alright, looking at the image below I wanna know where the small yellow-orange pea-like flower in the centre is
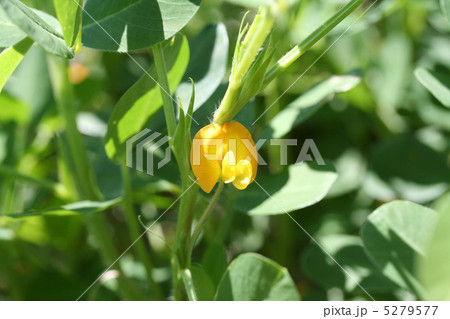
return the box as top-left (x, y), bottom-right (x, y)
top-left (191, 122), bottom-right (258, 193)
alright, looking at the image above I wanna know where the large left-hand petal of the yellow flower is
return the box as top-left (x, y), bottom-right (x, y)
top-left (190, 123), bottom-right (223, 193)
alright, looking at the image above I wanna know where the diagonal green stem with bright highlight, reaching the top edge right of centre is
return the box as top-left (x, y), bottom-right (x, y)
top-left (263, 0), bottom-right (366, 87)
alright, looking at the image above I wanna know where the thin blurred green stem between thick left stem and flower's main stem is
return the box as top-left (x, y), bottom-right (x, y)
top-left (122, 165), bottom-right (164, 300)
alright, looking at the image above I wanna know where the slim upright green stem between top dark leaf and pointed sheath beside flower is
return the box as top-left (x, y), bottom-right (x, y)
top-left (152, 43), bottom-right (176, 137)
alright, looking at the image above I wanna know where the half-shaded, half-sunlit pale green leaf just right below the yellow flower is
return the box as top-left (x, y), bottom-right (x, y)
top-left (234, 163), bottom-right (337, 215)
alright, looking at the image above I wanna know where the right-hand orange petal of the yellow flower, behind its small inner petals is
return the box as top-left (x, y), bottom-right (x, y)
top-left (223, 122), bottom-right (258, 188)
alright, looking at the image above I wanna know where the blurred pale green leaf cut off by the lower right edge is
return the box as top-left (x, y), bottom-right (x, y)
top-left (418, 193), bottom-right (450, 301)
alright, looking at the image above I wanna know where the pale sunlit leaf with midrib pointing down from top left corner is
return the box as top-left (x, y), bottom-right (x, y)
top-left (0, 0), bottom-right (74, 59)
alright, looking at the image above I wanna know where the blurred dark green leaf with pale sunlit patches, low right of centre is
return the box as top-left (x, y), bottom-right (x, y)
top-left (302, 235), bottom-right (397, 297)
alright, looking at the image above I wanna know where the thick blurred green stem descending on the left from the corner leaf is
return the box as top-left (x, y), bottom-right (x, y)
top-left (48, 56), bottom-right (143, 300)
